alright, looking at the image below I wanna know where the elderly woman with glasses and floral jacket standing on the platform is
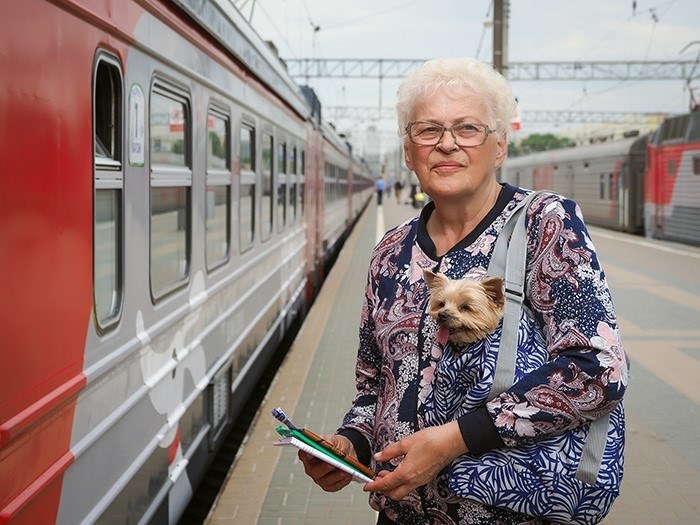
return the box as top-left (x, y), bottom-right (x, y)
top-left (300, 59), bottom-right (627, 525)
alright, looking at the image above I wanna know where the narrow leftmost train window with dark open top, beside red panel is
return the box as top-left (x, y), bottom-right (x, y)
top-left (93, 54), bottom-right (124, 329)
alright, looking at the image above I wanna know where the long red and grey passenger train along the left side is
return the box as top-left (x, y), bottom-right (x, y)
top-left (0, 0), bottom-right (373, 525)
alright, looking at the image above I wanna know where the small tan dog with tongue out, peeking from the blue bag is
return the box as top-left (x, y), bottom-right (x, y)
top-left (423, 270), bottom-right (505, 346)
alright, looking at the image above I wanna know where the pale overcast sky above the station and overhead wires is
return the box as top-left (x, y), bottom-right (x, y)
top-left (234, 0), bottom-right (700, 155)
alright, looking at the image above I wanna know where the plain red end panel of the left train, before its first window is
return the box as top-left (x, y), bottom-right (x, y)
top-left (0, 0), bottom-right (140, 524)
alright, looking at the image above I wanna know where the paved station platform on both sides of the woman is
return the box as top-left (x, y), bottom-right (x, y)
top-left (205, 195), bottom-right (700, 525)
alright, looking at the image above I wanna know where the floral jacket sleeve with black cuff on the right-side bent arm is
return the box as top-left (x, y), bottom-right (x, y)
top-left (470, 194), bottom-right (628, 453)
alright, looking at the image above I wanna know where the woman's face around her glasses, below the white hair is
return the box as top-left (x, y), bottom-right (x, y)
top-left (404, 90), bottom-right (507, 201)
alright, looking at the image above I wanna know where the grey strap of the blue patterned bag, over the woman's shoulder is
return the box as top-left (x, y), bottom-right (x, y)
top-left (487, 192), bottom-right (610, 485)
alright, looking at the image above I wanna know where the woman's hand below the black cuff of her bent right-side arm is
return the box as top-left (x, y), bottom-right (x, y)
top-left (364, 421), bottom-right (468, 501)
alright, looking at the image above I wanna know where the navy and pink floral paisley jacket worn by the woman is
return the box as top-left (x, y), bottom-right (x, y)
top-left (339, 185), bottom-right (627, 525)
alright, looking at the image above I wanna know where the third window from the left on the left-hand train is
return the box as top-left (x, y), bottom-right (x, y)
top-left (206, 110), bottom-right (231, 270)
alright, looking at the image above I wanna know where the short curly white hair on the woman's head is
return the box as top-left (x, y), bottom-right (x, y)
top-left (396, 58), bottom-right (517, 137)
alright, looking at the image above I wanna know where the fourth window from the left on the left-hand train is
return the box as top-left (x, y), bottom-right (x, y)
top-left (238, 124), bottom-right (255, 251)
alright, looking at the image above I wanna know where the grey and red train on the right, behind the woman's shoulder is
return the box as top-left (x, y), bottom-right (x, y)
top-left (502, 111), bottom-right (700, 245)
